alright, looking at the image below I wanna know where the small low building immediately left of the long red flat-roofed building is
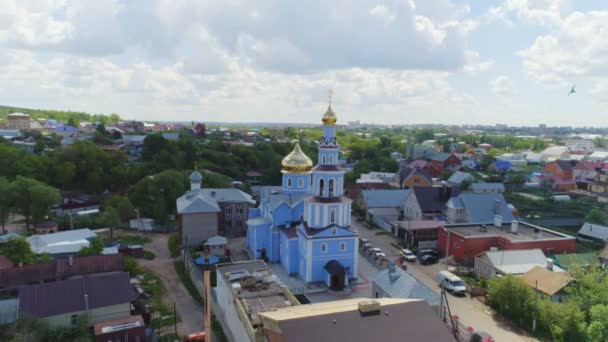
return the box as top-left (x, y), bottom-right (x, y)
top-left (394, 220), bottom-right (446, 248)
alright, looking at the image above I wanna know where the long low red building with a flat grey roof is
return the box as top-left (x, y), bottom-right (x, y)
top-left (438, 219), bottom-right (576, 265)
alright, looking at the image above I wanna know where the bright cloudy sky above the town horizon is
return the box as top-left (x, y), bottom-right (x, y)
top-left (0, 0), bottom-right (608, 126)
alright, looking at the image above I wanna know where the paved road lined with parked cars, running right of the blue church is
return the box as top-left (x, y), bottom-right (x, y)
top-left (352, 217), bottom-right (534, 342)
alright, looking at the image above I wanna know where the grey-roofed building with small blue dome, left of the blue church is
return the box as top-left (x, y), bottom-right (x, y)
top-left (176, 170), bottom-right (255, 246)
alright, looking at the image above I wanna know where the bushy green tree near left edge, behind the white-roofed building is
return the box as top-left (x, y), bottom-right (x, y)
top-left (10, 176), bottom-right (61, 229)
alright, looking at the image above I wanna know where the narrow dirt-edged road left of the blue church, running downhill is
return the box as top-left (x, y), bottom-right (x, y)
top-left (139, 234), bottom-right (204, 336)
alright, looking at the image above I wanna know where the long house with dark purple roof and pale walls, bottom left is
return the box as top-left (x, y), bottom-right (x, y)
top-left (19, 272), bottom-right (135, 327)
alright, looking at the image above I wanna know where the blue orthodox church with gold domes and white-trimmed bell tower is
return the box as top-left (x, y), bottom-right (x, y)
top-left (247, 104), bottom-right (359, 290)
